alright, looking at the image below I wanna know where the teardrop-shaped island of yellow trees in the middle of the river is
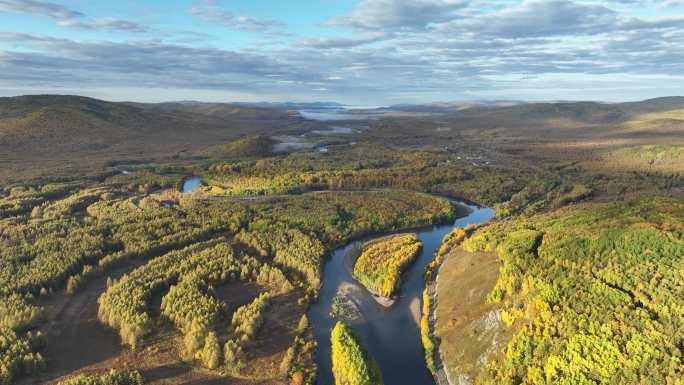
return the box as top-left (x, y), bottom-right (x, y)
top-left (354, 234), bottom-right (423, 305)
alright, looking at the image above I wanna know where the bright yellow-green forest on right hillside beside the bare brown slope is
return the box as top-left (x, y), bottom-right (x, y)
top-left (452, 197), bottom-right (684, 384)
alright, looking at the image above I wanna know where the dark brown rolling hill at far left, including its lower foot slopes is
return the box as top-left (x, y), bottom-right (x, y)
top-left (0, 95), bottom-right (312, 182)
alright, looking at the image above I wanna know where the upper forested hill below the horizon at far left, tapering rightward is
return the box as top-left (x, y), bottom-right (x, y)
top-left (0, 95), bottom-right (299, 159)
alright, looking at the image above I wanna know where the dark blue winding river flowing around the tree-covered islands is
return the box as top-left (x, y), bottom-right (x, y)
top-left (309, 205), bottom-right (494, 385)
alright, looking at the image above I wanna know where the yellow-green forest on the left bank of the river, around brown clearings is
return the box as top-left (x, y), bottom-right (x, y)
top-left (0, 172), bottom-right (454, 384)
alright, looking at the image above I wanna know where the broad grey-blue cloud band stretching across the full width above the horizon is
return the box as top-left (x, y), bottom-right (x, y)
top-left (0, 23), bottom-right (684, 104)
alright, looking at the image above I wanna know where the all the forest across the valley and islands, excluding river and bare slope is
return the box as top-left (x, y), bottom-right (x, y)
top-left (0, 94), bottom-right (684, 385)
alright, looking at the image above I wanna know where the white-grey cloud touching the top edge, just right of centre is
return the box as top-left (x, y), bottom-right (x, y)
top-left (329, 0), bottom-right (466, 30)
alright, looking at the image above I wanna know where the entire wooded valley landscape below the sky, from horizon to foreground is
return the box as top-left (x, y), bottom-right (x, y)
top-left (0, 96), bottom-right (684, 385)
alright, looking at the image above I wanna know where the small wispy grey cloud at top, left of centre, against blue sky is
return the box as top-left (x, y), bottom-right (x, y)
top-left (190, 0), bottom-right (285, 32)
